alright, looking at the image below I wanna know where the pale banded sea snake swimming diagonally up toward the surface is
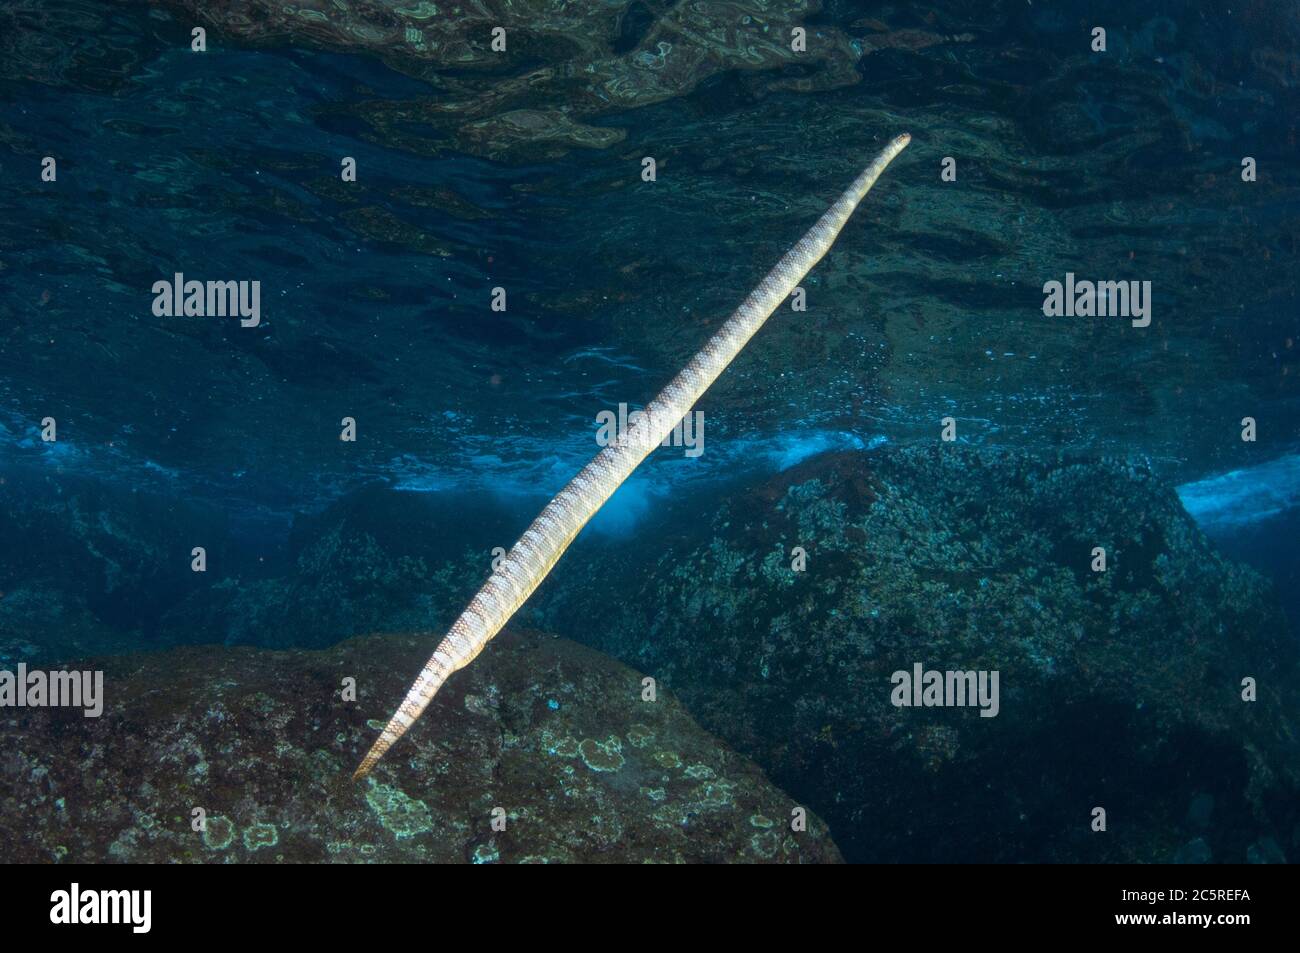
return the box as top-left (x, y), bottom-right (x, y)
top-left (352, 133), bottom-right (911, 779)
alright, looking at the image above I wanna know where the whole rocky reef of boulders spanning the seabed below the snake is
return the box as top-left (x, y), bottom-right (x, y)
top-left (0, 445), bottom-right (1300, 862)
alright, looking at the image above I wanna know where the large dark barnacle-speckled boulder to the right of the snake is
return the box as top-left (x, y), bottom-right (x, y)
top-left (529, 446), bottom-right (1300, 861)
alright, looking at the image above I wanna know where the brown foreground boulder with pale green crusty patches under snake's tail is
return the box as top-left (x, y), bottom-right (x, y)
top-left (0, 632), bottom-right (840, 863)
